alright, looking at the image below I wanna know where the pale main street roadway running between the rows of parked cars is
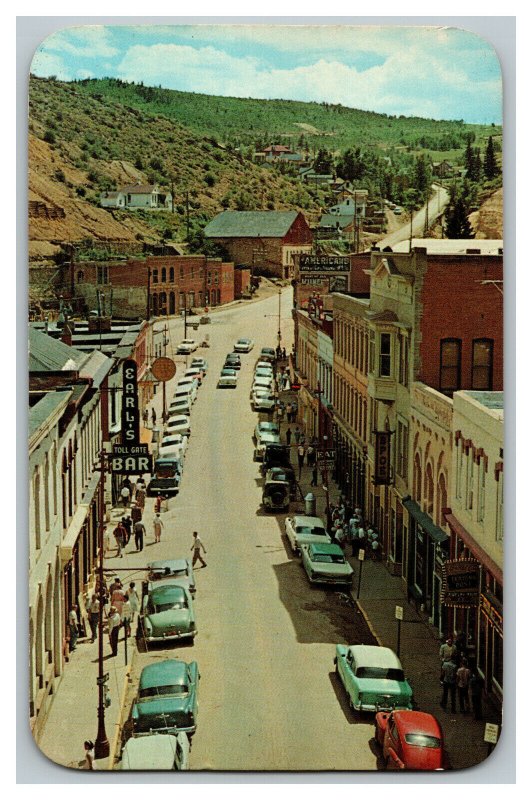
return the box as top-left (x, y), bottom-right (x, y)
top-left (118, 289), bottom-right (376, 770)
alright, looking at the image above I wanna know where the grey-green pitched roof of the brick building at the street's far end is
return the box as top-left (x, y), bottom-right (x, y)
top-left (204, 211), bottom-right (298, 238)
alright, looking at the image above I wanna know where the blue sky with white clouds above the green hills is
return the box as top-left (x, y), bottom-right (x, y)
top-left (32, 24), bottom-right (502, 124)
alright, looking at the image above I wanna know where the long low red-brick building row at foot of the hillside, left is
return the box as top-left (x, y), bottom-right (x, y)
top-left (71, 255), bottom-right (235, 319)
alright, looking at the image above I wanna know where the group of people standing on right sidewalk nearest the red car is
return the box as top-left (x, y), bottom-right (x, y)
top-left (440, 636), bottom-right (484, 719)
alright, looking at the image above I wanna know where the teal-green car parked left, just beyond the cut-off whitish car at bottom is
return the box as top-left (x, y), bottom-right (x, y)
top-left (132, 658), bottom-right (200, 734)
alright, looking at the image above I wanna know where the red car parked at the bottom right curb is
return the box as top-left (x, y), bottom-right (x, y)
top-left (375, 711), bottom-right (450, 770)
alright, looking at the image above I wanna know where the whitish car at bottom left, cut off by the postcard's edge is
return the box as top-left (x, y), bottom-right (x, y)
top-left (120, 731), bottom-right (190, 772)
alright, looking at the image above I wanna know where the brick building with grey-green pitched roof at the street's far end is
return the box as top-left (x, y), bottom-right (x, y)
top-left (204, 211), bottom-right (312, 279)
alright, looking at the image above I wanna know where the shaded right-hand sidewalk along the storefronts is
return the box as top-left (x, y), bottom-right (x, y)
top-left (281, 421), bottom-right (501, 769)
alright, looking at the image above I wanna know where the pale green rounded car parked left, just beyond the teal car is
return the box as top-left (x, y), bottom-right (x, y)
top-left (141, 581), bottom-right (198, 643)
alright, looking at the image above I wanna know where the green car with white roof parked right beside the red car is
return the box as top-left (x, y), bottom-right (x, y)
top-left (334, 644), bottom-right (412, 712)
